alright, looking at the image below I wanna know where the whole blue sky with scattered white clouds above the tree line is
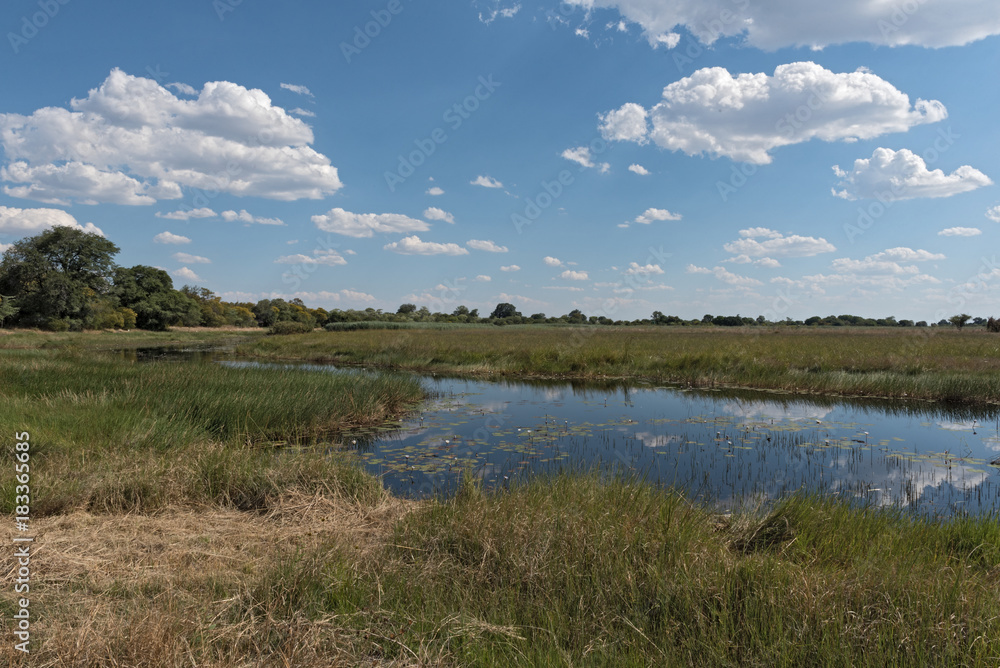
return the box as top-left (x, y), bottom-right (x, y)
top-left (0, 0), bottom-right (1000, 320)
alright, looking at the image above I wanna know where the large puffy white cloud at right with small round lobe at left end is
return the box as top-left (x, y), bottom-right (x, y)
top-left (600, 62), bottom-right (948, 165)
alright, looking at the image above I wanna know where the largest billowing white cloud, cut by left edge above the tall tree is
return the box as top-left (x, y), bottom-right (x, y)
top-left (0, 69), bottom-right (342, 205)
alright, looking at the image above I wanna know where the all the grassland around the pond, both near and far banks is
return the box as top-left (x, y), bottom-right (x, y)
top-left (0, 328), bottom-right (1000, 668)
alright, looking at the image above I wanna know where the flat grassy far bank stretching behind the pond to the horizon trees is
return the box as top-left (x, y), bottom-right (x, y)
top-left (238, 326), bottom-right (1000, 403)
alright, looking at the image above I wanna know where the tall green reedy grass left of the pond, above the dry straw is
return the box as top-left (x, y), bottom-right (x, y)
top-left (0, 350), bottom-right (422, 514)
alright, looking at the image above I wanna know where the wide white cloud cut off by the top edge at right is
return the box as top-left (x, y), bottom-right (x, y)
top-left (566, 0), bottom-right (1000, 51)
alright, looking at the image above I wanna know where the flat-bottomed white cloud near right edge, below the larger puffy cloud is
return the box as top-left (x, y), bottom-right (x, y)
top-left (833, 148), bottom-right (993, 201)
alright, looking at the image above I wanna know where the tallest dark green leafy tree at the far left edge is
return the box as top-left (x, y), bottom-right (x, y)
top-left (0, 226), bottom-right (119, 328)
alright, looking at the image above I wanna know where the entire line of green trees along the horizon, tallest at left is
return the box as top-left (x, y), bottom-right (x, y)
top-left (0, 227), bottom-right (988, 332)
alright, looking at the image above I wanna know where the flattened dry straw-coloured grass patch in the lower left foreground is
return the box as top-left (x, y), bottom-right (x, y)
top-left (0, 494), bottom-right (422, 668)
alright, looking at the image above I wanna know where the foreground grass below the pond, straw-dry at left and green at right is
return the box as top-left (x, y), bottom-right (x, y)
top-left (0, 475), bottom-right (1000, 668)
